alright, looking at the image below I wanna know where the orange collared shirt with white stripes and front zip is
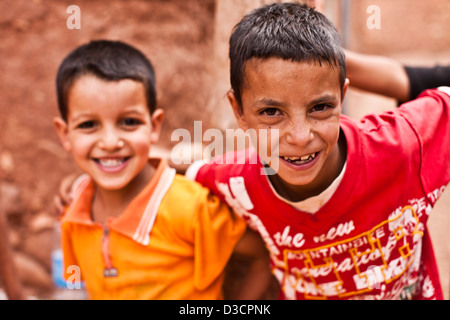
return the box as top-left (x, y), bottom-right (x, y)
top-left (61, 160), bottom-right (246, 300)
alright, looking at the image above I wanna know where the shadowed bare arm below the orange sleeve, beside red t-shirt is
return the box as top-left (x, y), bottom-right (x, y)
top-left (224, 228), bottom-right (278, 300)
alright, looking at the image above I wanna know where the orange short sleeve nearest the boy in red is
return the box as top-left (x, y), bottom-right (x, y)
top-left (194, 191), bottom-right (246, 290)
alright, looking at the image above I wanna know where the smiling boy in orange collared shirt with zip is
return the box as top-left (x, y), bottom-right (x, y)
top-left (54, 40), bottom-right (270, 299)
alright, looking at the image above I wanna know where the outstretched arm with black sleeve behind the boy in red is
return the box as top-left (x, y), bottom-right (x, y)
top-left (345, 50), bottom-right (450, 103)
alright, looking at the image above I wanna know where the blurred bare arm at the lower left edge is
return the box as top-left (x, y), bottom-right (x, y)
top-left (0, 211), bottom-right (25, 300)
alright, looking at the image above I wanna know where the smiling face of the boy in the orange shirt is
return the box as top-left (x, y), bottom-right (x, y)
top-left (54, 75), bottom-right (163, 190)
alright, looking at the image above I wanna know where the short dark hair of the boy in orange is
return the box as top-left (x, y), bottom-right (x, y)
top-left (56, 40), bottom-right (156, 121)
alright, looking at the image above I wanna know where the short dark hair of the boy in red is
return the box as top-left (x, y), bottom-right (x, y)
top-left (229, 3), bottom-right (346, 106)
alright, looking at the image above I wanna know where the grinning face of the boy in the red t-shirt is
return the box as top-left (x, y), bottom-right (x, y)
top-left (228, 58), bottom-right (348, 201)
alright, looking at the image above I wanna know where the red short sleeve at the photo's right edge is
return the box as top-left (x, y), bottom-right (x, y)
top-left (399, 89), bottom-right (450, 193)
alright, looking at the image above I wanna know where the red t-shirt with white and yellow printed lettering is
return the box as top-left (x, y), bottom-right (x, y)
top-left (188, 90), bottom-right (450, 299)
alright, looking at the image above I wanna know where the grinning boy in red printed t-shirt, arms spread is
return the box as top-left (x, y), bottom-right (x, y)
top-left (187, 3), bottom-right (450, 299)
